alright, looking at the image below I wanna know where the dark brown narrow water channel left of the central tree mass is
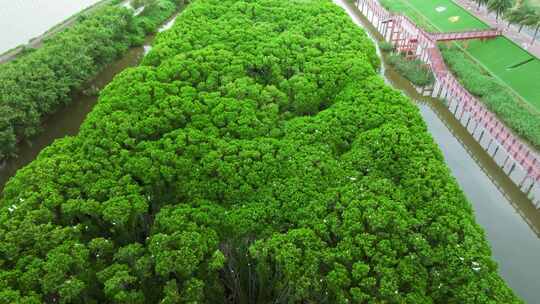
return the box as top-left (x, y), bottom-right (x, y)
top-left (0, 14), bottom-right (178, 192)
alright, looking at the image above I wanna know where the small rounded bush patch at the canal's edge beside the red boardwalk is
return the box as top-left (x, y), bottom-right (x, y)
top-left (387, 54), bottom-right (435, 87)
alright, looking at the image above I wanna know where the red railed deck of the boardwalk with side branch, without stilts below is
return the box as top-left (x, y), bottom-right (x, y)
top-left (358, 0), bottom-right (540, 181)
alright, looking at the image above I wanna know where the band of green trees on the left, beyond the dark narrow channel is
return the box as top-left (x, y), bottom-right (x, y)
top-left (0, 0), bottom-right (181, 162)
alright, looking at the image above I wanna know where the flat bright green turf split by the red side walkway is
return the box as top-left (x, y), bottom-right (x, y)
top-left (381, 0), bottom-right (540, 110)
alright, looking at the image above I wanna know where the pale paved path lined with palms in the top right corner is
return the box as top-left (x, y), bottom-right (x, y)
top-left (452, 0), bottom-right (540, 58)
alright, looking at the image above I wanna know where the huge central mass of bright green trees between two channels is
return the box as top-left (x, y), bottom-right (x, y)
top-left (0, 0), bottom-right (519, 303)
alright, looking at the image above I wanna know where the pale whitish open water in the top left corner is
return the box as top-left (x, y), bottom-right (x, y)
top-left (0, 0), bottom-right (101, 54)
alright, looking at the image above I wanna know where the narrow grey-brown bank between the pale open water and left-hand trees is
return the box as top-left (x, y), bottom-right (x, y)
top-left (0, 0), bottom-right (110, 64)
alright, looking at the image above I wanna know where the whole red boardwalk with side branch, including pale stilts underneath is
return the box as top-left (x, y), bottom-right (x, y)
top-left (356, 0), bottom-right (540, 208)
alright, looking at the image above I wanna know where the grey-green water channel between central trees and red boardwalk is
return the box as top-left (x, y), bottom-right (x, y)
top-left (334, 0), bottom-right (540, 303)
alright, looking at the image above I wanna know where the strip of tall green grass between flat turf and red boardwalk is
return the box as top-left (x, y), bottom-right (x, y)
top-left (441, 47), bottom-right (540, 147)
